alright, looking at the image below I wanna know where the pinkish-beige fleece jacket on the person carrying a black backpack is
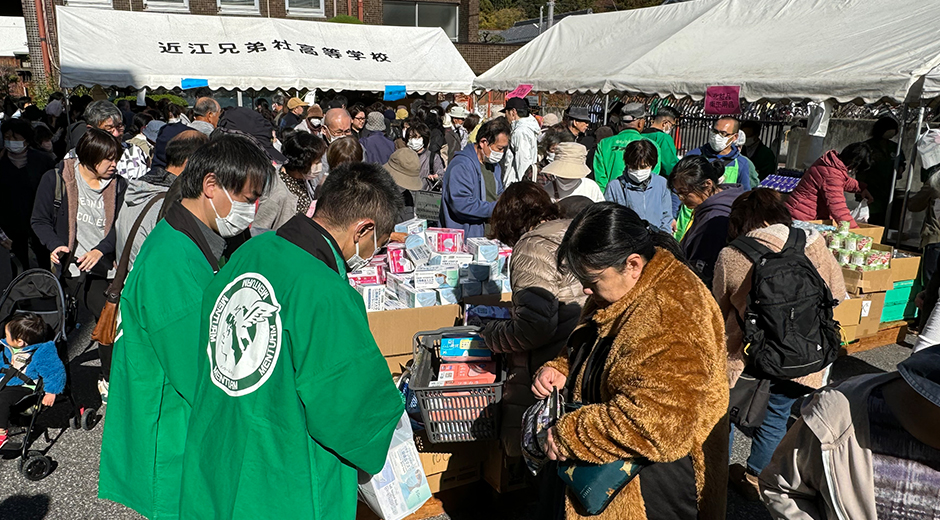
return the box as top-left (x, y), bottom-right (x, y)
top-left (712, 224), bottom-right (847, 388)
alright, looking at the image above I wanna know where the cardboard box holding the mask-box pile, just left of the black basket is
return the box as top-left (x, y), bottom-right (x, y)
top-left (368, 305), bottom-right (460, 357)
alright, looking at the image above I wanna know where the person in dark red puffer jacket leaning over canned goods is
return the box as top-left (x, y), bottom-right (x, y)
top-left (787, 143), bottom-right (874, 228)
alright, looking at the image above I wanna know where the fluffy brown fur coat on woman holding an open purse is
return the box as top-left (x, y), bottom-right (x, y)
top-left (546, 249), bottom-right (728, 520)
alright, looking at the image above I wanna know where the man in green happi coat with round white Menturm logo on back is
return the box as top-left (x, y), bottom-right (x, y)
top-left (180, 163), bottom-right (404, 520)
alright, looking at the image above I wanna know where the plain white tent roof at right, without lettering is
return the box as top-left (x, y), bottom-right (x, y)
top-left (474, 0), bottom-right (940, 102)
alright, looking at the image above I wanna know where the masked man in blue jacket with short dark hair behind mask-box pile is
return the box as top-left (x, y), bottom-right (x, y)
top-left (440, 117), bottom-right (512, 238)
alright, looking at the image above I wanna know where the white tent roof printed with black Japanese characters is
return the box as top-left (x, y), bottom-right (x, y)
top-left (56, 7), bottom-right (474, 93)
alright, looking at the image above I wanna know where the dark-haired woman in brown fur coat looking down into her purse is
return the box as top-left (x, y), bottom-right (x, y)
top-left (532, 203), bottom-right (728, 520)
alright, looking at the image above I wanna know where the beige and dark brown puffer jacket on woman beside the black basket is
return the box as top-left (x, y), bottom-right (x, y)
top-left (483, 220), bottom-right (587, 456)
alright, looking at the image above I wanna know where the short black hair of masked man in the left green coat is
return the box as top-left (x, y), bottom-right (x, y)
top-left (178, 133), bottom-right (276, 199)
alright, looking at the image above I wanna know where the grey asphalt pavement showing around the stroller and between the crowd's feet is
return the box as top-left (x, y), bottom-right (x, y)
top-left (0, 304), bottom-right (912, 520)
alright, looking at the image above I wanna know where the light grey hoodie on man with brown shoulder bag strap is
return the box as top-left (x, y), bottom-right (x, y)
top-left (115, 166), bottom-right (176, 270)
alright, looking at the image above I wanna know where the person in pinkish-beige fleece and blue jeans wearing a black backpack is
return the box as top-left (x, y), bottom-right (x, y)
top-left (712, 188), bottom-right (846, 501)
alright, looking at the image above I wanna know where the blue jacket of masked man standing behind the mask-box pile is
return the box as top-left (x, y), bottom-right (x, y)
top-left (441, 143), bottom-right (503, 238)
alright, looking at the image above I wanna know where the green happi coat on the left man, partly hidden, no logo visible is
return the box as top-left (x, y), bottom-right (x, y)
top-left (98, 204), bottom-right (220, 519)
